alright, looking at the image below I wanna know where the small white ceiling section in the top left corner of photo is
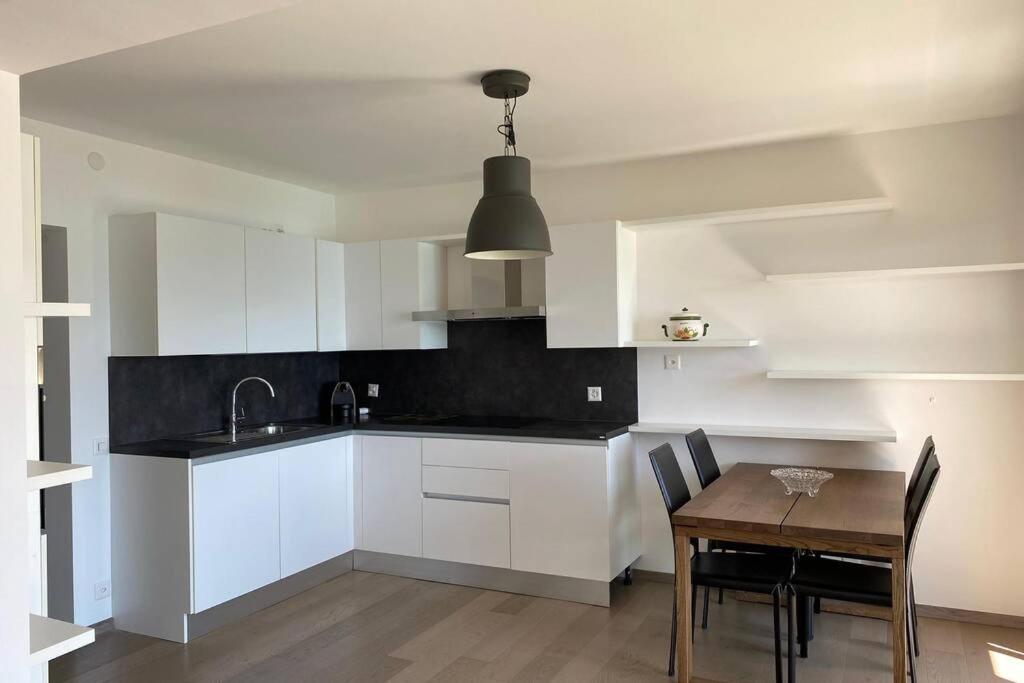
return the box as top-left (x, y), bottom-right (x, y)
top-left (0, 0), bottom-right (297, 74)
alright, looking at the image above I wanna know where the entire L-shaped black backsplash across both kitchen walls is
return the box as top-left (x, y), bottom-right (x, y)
top-left (108, 319), bottom-right (637, 444)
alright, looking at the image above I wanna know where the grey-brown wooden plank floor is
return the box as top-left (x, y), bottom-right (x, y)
top-left (50, 571), bottom-right (1024, 683)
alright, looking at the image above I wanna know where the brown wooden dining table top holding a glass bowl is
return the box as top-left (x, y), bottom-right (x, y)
top-left (672, 463), bottom-right (906, 547)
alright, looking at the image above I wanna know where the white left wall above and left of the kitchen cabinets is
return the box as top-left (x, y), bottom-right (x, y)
top-left (22, 120), bottom-right (335, 624)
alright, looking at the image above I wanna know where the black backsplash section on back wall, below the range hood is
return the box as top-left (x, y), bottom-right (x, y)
top-left (341, 319), bottom-right (637, 422)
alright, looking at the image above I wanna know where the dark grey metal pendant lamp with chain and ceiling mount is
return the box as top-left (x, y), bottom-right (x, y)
top-left (466, 69), bottom-right (551, 261)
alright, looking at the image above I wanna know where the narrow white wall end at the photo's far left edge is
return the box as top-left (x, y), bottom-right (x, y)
top-left (0, 72), bottom-right (29, 682)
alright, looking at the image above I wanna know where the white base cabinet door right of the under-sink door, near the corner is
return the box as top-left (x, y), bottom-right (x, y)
top-left (278, 438), bottom-right (352, 577)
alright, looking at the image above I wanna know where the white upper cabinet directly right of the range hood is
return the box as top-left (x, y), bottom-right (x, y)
top-left (545, 221), bottom-right (637, 348)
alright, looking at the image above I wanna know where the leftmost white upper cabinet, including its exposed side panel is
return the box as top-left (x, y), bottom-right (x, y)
top-left (109, 213), bottom-right (252, 355)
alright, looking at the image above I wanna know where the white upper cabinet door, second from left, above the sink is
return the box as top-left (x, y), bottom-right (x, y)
top-left (246, 227), bottom-right (316, 353)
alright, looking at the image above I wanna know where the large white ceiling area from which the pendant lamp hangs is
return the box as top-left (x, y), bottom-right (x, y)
top-left (16, 0), bottom-right (1024, 190)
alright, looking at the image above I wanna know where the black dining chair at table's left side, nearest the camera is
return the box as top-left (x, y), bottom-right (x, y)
top-left (649, 443), bottom-right (795, 683)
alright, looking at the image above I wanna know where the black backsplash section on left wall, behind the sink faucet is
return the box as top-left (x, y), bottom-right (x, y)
top-left (106, 353), bottom-right (338, 444)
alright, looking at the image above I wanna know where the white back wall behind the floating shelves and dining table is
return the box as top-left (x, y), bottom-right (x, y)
top-left (337, 118), bottom-right (1024, 615)
